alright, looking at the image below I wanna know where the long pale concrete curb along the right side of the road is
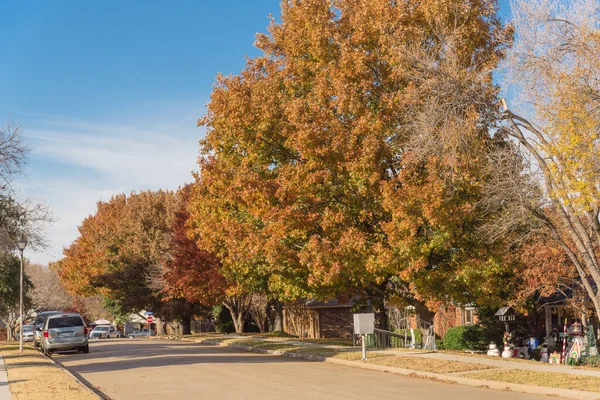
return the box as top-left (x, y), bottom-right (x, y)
top-left (184, 339), bottom-right (600, 400)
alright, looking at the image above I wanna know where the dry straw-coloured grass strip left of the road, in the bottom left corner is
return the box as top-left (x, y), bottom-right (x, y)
top-left (0, 344), bottom-right (97, 400)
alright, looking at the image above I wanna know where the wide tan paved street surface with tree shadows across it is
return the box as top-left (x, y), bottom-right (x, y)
top-left (53, 339), bottom-right (547, 400)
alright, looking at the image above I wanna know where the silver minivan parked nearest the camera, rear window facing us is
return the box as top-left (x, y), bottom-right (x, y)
top-left (40, 313), bottom-right (90, 355)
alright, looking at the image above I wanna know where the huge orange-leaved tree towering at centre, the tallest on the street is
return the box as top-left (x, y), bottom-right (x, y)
top-left (190, 0), bottom-right (510, 318)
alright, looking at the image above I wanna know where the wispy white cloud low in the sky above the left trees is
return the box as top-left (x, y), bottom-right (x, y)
top-left (17, 110), bottom-right (204, 263)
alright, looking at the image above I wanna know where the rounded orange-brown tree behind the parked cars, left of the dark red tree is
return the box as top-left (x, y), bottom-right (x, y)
top-left (57, 191), bottom-right (174, 312)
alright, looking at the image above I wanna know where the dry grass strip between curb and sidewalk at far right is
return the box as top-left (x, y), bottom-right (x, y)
top-left (463, 369), bottom-right (600, 393)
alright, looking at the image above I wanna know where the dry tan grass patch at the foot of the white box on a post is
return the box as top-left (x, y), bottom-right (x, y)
top-left (369, 356), bottom-right (494, 374)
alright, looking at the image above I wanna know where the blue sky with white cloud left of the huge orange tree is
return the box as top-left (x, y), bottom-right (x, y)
top-left (0, 0), bottom-right (508, 263)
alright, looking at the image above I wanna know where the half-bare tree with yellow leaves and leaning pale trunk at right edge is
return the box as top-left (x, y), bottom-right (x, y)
top-left (485, 0), bottom-right (600, 315)
